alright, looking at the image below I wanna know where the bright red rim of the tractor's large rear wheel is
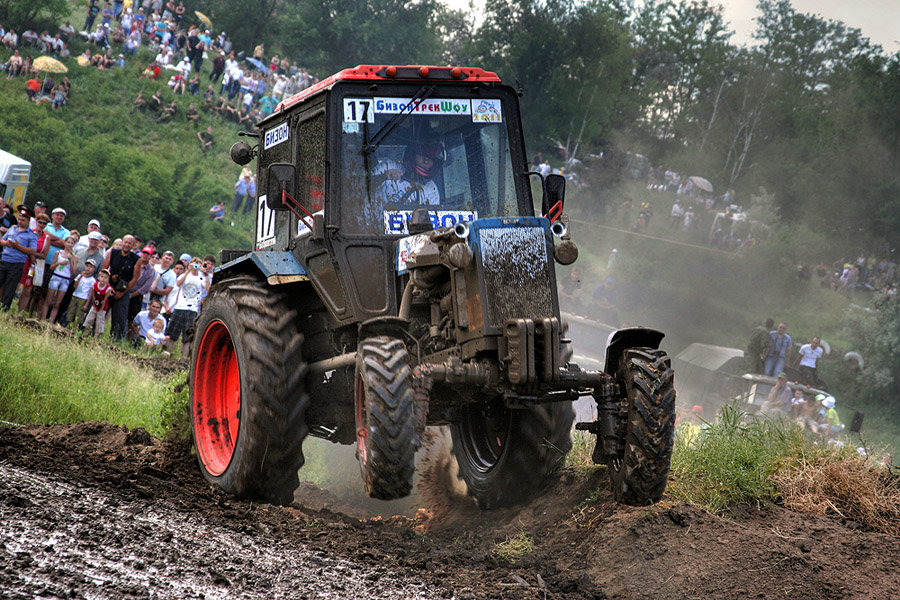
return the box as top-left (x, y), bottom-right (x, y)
top-left (191, 321), bottom-right (241, 476)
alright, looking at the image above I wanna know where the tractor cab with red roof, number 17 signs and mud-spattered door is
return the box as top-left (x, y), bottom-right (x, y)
top-left (232, 65), bottom-right (533, 324)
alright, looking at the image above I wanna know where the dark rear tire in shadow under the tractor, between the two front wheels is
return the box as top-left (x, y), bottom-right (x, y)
top-left (450, 399), bottom-right (575, 510)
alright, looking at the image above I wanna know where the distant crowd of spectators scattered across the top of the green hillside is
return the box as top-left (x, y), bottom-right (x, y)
top-left (0, 0), bottom-right (318, 130)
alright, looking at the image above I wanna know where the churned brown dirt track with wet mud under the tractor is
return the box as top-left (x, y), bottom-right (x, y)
top-left (0, 423), bottom-right (900, 600)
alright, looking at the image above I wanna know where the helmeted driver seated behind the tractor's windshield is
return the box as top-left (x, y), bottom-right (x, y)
top-left (377, 143), bottom-right (443, 205)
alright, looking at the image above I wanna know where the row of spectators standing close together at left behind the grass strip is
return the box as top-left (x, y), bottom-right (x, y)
top-left (0, 200), bottom-right (216, 355)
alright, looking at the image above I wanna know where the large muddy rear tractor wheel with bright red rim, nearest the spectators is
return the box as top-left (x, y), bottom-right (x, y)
top-left (190, 276), bottom-right (309, 505)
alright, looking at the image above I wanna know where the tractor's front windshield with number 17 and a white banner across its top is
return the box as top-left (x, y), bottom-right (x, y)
top-left (341, 96), bottom-right (519, 235)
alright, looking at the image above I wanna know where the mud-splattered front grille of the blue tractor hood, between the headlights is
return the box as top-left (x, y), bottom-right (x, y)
top-left (480, 227), bottom-right (555, 327)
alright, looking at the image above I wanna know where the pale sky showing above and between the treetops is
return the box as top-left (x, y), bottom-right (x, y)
top-left (444, 0), bottom-right (900, 54)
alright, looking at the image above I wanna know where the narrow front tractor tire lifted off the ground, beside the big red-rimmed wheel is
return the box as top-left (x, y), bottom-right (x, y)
top-left (354, 336), bottom-right (417, 500)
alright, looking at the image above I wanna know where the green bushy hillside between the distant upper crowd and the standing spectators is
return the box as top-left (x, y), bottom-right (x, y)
top-left (0, 34), bottom-right (253, 254)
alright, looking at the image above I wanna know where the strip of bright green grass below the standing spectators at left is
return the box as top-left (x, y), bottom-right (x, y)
top-left (0, 315), bottom-right (186, 437)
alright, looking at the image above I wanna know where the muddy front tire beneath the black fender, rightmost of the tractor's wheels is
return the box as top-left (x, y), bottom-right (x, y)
top-left (607, 348), bottom-right (675, 506)
